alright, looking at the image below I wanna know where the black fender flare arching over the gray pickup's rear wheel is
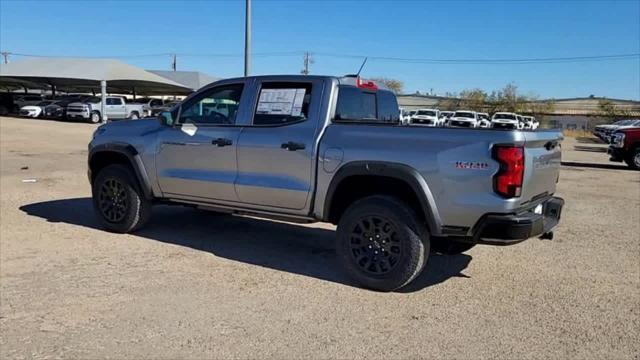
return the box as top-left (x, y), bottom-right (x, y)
top-left (323, 161), bottom-right (442, 236)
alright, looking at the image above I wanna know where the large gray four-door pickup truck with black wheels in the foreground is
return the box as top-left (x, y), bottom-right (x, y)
top-left (88, 76), bottom-right (564, 291)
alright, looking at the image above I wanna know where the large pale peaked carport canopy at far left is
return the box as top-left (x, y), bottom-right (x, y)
top-left (0, 58), bottom-right (193, 95)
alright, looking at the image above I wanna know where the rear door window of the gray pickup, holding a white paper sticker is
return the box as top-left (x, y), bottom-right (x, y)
top-left (252, 83), bottom-right (312, 126)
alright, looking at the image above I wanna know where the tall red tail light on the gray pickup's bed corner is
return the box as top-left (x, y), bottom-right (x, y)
top-left (493, 146), bottom-right (524, 198)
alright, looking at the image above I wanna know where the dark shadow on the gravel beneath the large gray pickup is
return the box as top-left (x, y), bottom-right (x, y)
top-left (20, 198), bottom-right (471, 292)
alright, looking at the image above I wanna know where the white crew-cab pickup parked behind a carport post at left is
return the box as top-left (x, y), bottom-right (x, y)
top-left (67, 96), bottom-right (144, 124)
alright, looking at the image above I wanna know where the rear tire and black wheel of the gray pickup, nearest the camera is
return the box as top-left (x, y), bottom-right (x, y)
top-left (336, 196), bottom-right (430, 291)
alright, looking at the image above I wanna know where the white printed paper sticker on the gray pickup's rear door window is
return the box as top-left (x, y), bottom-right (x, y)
top-left (256, 88), bottom-right (306, 116)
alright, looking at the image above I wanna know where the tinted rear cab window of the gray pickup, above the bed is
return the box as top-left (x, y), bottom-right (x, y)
top-left (334, 86), bottom-right (400, 123)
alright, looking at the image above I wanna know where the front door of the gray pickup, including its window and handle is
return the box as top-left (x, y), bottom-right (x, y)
top-left (156, 83), bottom-right (244, 201)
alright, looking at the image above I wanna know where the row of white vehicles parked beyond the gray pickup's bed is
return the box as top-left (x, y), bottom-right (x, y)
top-left (400, 109), bottom-right (540, 130)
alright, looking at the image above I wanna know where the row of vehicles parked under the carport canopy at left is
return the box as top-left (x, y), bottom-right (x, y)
top-left (0, 93), bottom-right (177, 123)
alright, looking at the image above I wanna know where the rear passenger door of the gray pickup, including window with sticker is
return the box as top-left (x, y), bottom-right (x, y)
top-left (235, 78), bottom-right (323, 210)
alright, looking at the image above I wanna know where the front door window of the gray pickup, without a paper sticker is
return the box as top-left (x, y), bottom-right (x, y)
top-left (179, 84), bottom-right (244, 125)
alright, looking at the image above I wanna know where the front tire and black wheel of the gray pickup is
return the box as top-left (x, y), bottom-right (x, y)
top-left (91, 164), bottom-right (151, 233)
